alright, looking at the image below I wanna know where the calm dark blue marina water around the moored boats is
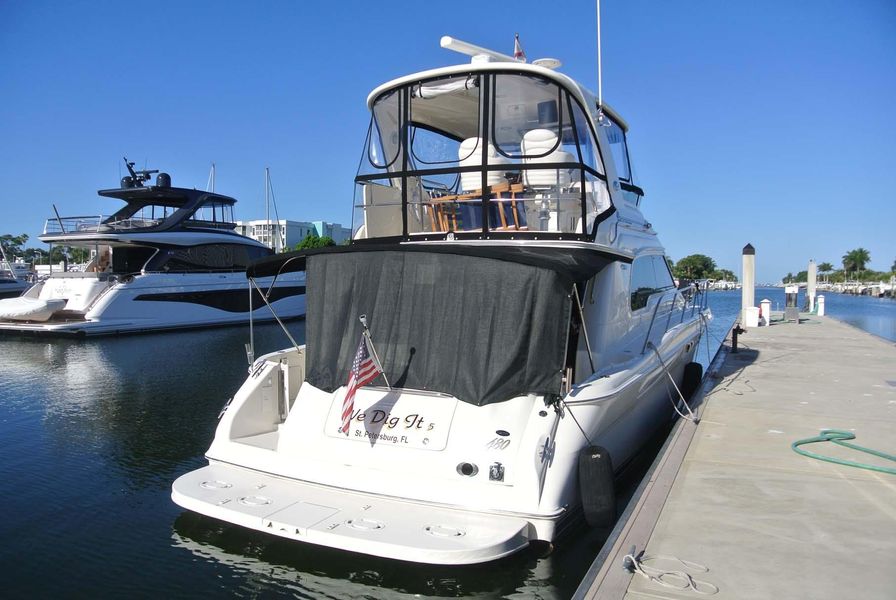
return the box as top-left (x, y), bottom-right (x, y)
top-left (0, 290), bottom-right (884, 598)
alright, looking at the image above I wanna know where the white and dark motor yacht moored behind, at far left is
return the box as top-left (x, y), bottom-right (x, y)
top-left (0, 161), bottom-right (305, 335)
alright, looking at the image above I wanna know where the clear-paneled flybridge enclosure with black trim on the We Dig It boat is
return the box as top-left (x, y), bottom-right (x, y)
top-left (353, 73), bottom-right (611, 240)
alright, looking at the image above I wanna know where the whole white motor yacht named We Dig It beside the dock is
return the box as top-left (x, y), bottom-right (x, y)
top-left (172, 38), bottom-right (710, 564)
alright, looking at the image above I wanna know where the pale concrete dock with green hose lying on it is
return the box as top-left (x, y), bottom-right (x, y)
top-left (575, 315), bottom-right (896, 600)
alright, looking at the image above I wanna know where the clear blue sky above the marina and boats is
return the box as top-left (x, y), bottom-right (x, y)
top-left (0, 0), bottom-right (896, 282)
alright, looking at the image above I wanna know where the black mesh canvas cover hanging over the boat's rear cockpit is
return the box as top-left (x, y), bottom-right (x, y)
top-left (305, 251), bottom-right (572, 405)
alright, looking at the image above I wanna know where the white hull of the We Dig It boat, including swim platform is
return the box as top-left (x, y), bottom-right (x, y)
top-left (172, 314), bottom-right (699, 564)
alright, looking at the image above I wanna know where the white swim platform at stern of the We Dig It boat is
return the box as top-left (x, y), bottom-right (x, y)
top-left (171, 464), bottom-right (531, 565)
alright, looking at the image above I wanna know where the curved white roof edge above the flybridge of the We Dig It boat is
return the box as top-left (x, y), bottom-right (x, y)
top-left (367, 61), bottom-right (628, 131)
